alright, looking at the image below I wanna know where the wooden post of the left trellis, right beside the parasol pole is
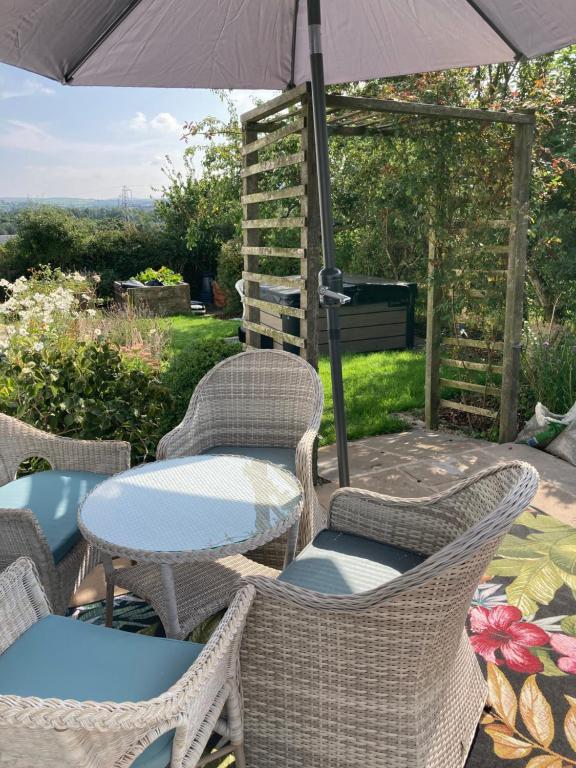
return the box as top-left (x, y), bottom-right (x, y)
top-left (300, 84), bottom-right (322, 369)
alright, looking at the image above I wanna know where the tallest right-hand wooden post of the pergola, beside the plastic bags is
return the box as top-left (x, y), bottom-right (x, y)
top-left (499, 123), bottom-right (534, 443)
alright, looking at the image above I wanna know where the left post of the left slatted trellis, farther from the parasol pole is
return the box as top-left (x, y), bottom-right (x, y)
top-left (242, 126), bottom-right (261, 348)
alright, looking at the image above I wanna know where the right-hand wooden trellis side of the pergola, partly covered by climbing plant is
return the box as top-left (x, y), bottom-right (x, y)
top-left (426, 123), bottom-right (533, 442)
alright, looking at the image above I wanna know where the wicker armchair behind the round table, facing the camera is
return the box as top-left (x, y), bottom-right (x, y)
top-left (156, 350), bottom-right (325, 568)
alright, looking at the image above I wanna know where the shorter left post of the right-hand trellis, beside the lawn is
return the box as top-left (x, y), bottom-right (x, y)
top-left (424, 229), bottom-right (442, 429)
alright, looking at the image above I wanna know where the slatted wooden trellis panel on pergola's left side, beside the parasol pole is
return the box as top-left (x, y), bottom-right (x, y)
top-left (241, 86), bottom-right (321, 366)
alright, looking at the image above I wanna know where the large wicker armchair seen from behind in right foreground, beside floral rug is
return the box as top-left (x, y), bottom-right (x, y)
top-left (240, 462), bottom-right (538, 768)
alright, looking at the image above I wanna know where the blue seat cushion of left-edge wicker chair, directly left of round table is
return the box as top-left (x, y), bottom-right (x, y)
top-left (0, 469), bottom-right (108, 563)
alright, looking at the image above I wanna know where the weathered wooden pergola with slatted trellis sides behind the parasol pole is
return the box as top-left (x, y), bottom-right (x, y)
top-left (241, 85), bottom-right (535, 441)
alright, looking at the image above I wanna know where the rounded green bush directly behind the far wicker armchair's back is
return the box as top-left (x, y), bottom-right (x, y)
top-left (162, 339), bottom-right (242, 426)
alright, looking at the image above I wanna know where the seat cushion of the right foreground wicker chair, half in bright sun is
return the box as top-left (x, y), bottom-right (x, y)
top-left (278, 531), bottom-right (426, 595)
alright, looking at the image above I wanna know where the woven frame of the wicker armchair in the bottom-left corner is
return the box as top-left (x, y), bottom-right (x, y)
top-left (0, 558), bottom-right (253, 768)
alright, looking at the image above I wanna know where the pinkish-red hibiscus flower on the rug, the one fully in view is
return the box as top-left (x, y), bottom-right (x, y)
top-left (470, 605), bottom-right (548, 674)
